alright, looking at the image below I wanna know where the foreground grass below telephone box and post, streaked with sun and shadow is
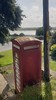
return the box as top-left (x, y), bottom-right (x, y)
top-left (21, 79), bottom-right (56, 100)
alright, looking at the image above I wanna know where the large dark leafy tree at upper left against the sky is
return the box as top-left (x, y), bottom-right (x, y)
top-left (0, 0), bottom-right (24, 44)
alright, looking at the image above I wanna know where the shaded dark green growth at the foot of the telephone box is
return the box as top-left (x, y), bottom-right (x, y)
top-left (22, 84), bottom-right (42, 100)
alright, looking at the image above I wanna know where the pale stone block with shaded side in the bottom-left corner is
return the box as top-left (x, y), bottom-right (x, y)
top-left (0, 74), bottom-right (16, 100)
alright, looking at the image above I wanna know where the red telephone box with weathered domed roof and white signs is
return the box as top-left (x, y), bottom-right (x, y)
top-left (12, 37), bottom-right (41, 93)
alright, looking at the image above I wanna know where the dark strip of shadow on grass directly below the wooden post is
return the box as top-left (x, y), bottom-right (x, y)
top-left (45, 82), bottom-right (53, 100)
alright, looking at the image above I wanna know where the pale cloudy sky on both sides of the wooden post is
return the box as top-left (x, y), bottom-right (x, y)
top-left (17, 0), bottom-right (56, 27)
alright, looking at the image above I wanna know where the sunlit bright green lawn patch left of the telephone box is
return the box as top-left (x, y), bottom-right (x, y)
top-left (0, 50), bottom-right (13, 67)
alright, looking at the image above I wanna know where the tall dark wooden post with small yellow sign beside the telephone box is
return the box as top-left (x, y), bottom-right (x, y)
top-left (43, 0), bottom-right (50, 82)
